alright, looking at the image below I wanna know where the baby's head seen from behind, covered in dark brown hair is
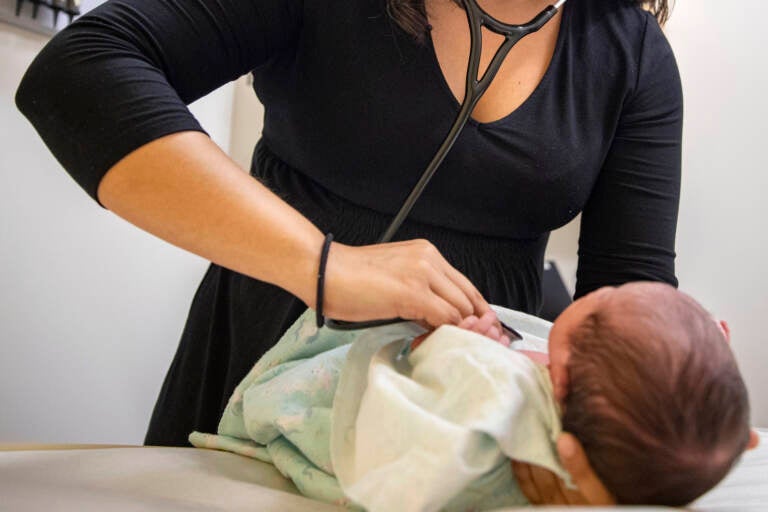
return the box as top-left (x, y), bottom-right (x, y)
top-left (563, 283), bottom-right (749, 506)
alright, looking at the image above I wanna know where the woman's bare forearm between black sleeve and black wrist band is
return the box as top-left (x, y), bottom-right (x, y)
top-left (98, 132), bottom-right (323, 306)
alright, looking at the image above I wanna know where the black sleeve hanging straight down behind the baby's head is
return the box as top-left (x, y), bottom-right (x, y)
top-left (575, 15), bottom-right (683, 297)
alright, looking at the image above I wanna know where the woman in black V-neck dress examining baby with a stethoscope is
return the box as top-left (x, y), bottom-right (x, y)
top-left (17, 0), bottom-right (682, 504)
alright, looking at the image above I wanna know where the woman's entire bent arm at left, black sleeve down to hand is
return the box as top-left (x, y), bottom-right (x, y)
top-left (17, 0), bottom-right (489, 325)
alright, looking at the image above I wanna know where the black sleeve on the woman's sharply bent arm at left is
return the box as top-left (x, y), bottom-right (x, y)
top-left (16, 0), bottom-right (302, 205)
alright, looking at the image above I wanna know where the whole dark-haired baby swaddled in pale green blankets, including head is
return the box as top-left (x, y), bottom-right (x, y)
top-left (190, 284), bottom-right (749, 510)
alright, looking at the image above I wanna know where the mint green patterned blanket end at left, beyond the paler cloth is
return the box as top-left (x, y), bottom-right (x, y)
top-left (189, 310), bottom-right (361, 505)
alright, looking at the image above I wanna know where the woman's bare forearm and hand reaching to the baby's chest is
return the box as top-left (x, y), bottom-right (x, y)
top-left (98, 132), bottom-right (484, 325)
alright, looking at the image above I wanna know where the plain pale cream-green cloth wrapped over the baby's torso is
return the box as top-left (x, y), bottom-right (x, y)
top-left (331, 324), bottom-right (567, 512)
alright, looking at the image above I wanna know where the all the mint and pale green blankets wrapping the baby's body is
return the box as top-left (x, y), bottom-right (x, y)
top-left (190, 309), bottom-right (566, 511)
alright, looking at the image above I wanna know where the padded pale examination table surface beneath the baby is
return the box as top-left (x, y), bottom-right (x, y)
top-left (0, 430), bottom-right (768, 512)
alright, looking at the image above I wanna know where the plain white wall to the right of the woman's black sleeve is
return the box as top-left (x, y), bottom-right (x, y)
top-left (667, 0), bottom-right (768, 426)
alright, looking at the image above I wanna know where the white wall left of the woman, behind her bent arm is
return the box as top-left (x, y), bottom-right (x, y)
top-left (0, 23), bottom-right (233, 443)
